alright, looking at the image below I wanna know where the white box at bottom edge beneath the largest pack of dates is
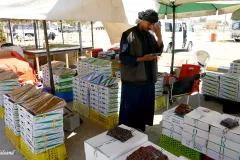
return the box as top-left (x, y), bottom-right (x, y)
top-left (115, 141), bottom-right (178, 160)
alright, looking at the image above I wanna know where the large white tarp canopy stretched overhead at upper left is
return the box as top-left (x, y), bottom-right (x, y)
top-left (0, 0), bottom-right (159, 24)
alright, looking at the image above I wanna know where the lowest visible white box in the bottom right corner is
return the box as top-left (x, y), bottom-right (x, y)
top-left (208, 141), bottom-right (240, 160)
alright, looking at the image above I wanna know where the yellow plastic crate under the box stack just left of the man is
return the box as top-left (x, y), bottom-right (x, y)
top-left (90, 109), bottom-right (118, 130)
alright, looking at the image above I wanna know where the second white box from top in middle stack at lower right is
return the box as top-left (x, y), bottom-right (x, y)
top-left (183, 123), bottom-right (209, 139)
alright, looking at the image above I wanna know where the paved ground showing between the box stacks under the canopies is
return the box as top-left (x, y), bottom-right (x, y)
top-left (0, 95), bottom-right (225, 160)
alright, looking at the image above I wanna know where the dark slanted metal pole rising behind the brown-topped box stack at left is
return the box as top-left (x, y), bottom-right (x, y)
top-left (43, 20), bottom-right (55, 95)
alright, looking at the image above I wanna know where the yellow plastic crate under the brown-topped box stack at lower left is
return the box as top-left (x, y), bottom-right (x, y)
top-left (20, 139), bottom-right (68, 160)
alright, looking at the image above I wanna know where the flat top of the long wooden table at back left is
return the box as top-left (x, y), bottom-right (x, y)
top-left (23, 46), bottom-right (92, 57)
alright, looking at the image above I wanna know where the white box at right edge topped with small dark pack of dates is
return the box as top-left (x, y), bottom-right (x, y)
top-left (210, 114), bottom-right (240, 144)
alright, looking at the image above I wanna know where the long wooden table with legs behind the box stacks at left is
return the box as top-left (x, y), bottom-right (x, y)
top-left (23, 46), bottom-right (92, 78)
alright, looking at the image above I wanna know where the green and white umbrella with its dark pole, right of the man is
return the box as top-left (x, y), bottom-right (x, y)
top-left (158, 0), bottom-right (240, 74)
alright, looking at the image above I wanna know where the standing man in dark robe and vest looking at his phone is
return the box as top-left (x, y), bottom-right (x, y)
top-left (119, 10), bottom-right (163, 132)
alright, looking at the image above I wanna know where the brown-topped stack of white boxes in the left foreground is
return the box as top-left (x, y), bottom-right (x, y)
top-left (4, 85), bottom-right (66, 154)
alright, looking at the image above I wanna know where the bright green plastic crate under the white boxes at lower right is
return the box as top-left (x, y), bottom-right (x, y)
top-left (159, 135), bottom-right (202, 160)
